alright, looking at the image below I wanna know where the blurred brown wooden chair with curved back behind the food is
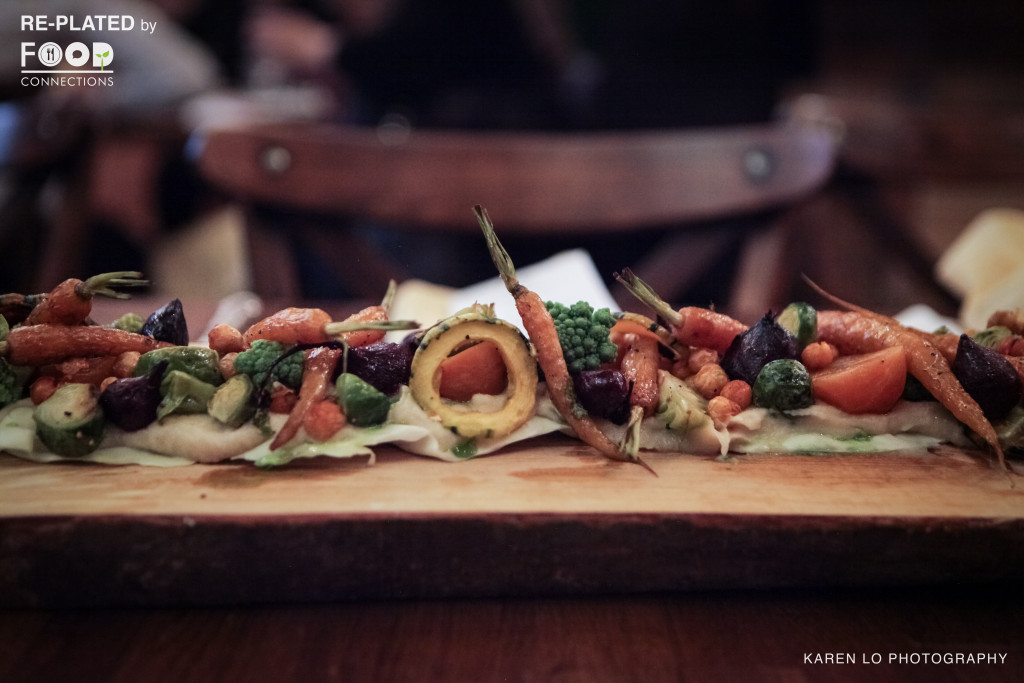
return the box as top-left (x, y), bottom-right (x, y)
top-left (197, 123), bottom-right (836, 315)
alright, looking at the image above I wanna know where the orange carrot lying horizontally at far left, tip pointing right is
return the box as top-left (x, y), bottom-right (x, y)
top-left (0, 325), bottom-right (170, 367)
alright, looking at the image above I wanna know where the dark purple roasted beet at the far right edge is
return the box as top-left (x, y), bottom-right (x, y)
top-left (952, 335), bottom-right (1024, 420)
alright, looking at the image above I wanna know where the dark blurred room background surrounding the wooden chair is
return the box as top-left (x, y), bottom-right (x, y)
top-left (0, 0), bottom-right (1024, 309)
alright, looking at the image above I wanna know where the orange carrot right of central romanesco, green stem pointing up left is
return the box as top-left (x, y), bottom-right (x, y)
top-left (615, 268), bottom-right (746, 353)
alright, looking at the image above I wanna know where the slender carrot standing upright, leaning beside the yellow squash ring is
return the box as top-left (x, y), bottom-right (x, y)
top-left (473, 206), bottom-right (634, 466)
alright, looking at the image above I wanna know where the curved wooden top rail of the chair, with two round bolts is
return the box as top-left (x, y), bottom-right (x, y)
top-left (198, 122), bottom-right (836, 309)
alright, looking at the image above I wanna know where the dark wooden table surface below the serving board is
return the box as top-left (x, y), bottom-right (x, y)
top-left (0, 586), bottom-right (1024, 683)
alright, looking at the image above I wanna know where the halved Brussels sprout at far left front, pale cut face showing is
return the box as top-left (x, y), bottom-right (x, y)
top-left (33, 384), bottom-right (106, 458)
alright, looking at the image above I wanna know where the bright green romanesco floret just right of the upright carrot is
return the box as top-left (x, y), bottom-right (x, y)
top-left (545, 301), bottom-right (618, 374)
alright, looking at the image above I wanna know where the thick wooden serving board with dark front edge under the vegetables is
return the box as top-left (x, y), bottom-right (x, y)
top-left (0, 436), bottom-right (1024, 606)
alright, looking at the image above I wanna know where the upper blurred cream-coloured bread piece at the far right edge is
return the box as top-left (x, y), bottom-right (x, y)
top-left (935, 208), bottom-right (1024, 296)
